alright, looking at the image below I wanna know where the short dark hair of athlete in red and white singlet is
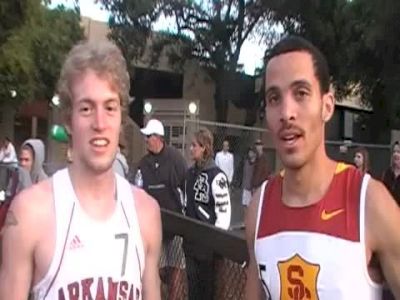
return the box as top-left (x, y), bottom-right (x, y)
top-left (265, 35), bottom-right (330, 94)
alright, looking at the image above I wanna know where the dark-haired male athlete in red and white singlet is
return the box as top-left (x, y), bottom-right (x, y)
top-left (246, 37), bottom-right (400, 300)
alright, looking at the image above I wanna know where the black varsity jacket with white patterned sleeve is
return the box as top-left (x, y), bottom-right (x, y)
top-left (185, 160), bottom-right (231, 229)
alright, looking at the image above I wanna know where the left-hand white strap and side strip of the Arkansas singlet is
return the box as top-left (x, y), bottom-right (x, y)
top-left (43, 169), bottom-right (75, 299)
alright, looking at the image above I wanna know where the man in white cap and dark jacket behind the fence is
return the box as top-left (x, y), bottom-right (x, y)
top-left (139, 119), bottom-right (187, 299)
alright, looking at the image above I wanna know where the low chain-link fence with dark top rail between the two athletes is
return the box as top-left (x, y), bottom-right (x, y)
top-left (160, 209), bottom-right (248, 300)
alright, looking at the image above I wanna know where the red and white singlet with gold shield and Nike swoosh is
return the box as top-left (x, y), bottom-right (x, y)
top-left (255, 163), bottom-right (382, 300)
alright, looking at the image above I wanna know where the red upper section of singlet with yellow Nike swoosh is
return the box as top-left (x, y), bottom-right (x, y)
top-left (257, 164), bottom-right (363, 242)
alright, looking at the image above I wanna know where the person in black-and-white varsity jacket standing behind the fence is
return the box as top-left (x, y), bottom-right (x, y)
top-left (184, 129), bottom-right (231, 300)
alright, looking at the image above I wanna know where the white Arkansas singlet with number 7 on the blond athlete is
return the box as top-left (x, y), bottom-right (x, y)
top-left (31, 169), bottom-right (144, 300)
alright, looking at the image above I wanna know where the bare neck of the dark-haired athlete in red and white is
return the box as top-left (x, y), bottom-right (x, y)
top-left (282, 150), bottom-right (337, 207)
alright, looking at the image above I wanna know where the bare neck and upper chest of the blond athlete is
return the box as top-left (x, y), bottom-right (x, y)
top-left (68, 163), bottom-right (116, 219)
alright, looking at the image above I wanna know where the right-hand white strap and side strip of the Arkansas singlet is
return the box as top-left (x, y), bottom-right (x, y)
top-left (115, 174), bottom-right (145, 277)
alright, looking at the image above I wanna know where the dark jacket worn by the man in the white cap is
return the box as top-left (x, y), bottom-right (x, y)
top-left (139, 145), bottom-right (187, 213)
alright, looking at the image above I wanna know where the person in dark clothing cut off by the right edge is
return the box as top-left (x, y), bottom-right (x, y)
top-left (382, 141), bottom-right (400, 205)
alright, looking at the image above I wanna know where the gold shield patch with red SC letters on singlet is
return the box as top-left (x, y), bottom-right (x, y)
top-left (278, 254), bottom-right (320, 300)
